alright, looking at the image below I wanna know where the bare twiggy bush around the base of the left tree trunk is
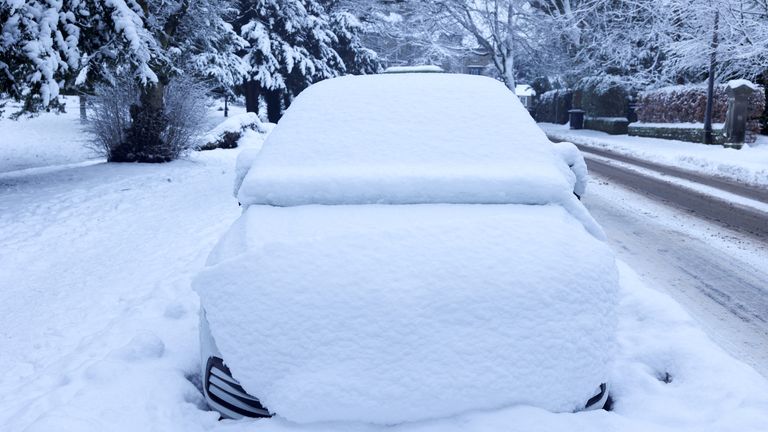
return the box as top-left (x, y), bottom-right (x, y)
top-left (89, 77), bottom-right (208, 162)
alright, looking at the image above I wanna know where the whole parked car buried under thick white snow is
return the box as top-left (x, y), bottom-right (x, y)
top-left (193, 74), bottom-right (618, 424)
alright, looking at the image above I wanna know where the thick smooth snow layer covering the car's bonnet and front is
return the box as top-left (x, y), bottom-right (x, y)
top-left (194, 204), bottom-right (618, 424)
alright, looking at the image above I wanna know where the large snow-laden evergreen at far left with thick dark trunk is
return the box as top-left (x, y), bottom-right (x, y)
top-left (0, 0), bottom-right (245, 161)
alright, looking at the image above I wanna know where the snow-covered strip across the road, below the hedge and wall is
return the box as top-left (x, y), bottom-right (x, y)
top-left (539, 123), bottom-right (768, 185)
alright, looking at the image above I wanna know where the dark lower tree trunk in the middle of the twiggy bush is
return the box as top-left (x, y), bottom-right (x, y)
top-left (115, 83), bottom-right (169, 163)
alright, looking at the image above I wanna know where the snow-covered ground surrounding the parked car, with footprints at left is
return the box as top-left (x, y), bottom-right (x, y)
top-left (0, 109), bottom-right (768, 432)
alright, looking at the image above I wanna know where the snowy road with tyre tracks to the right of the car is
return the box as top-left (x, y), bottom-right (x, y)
top-left (584, 170), bottom-right (768, 376)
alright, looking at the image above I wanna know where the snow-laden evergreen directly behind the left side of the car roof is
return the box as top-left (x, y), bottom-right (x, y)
top-left (240, 0), bottom-right (378, 122)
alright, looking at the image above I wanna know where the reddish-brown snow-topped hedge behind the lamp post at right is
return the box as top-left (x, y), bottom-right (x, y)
top-left (637, 84), bottom-right (765, 141)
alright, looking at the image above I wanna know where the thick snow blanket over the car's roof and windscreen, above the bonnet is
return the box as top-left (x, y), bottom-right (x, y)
top-left (238, 74), bottom-right (572, 206)
